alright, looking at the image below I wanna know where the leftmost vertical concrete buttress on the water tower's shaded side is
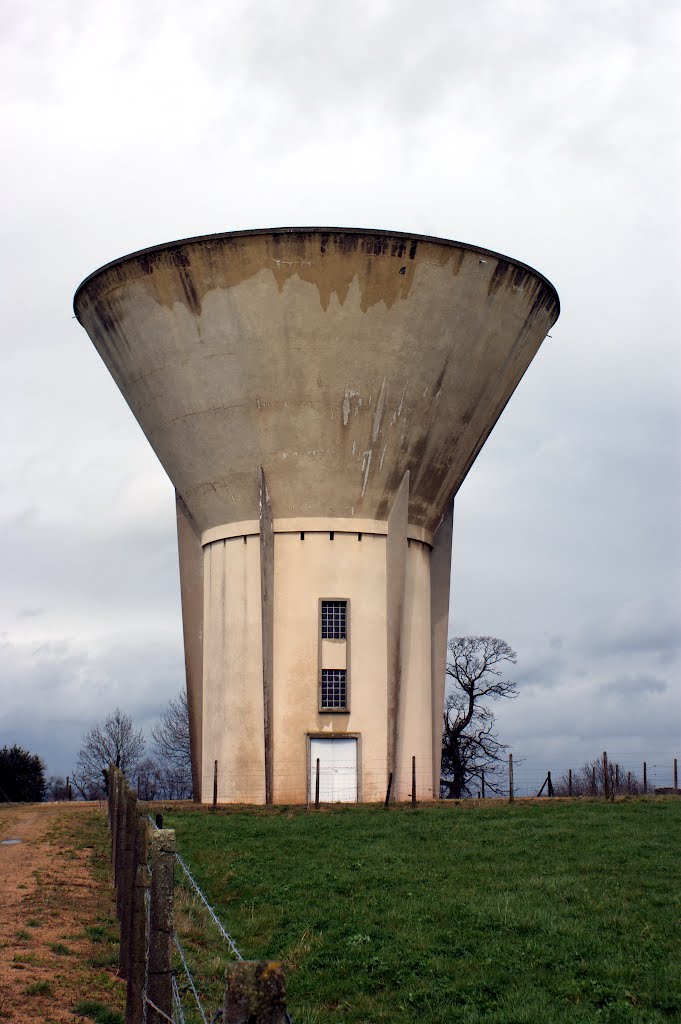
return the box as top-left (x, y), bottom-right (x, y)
top-left (175, 492), bottom-right (204, 802)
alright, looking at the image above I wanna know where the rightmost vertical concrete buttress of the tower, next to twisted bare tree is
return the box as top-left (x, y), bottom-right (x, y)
top-left (430, 499), bottom-right (454, 798)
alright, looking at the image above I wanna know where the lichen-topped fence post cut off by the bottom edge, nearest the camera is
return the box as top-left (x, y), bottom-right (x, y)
top-left (222, 961), bottom-right (286, 1024)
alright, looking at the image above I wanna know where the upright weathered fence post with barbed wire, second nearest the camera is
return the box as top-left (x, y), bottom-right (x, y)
top-left (146, 828), bottom-right (175, 1024)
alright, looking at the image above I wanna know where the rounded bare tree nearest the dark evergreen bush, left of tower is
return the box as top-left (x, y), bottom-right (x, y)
top-left (72, 708), bottom-right (145, 800)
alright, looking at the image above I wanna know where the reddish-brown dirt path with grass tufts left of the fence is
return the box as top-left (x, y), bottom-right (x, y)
top-left (0, 803), bottom-right (124, 1024)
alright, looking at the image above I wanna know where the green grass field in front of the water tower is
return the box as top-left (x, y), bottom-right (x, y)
top-left (165, 798), bottom-right (681, 1024)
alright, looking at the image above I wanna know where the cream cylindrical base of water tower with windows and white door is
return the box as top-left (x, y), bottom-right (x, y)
top-left (180, 519), bottom-right (451, 804)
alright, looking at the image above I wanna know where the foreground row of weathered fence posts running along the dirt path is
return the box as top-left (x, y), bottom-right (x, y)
top-left (108, 765), bottom-right (290, 1024)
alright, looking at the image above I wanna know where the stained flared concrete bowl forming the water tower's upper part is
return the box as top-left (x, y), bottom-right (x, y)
top-left (75, 229), bottom-right (558, 531)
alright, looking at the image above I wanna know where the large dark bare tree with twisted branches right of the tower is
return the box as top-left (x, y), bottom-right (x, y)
top-left (440, 636), bottom-right (518, 799)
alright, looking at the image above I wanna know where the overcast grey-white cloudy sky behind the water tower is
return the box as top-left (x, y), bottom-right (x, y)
top-left (0, 0), bottom-right (681, 785)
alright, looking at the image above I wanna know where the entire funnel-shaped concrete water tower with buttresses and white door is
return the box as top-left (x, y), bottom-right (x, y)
top-left (75, 228), bottom-right (559, 803)
